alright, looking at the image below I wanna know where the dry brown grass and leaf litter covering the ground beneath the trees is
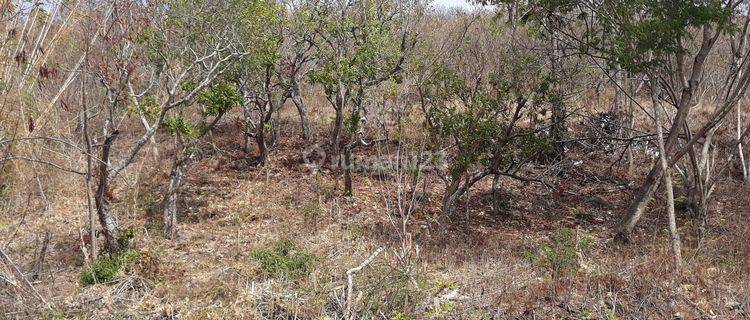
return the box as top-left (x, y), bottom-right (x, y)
top-left (0, 98), bottom-right (750, 319)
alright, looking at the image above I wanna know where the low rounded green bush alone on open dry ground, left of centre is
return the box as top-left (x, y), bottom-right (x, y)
top-left (252, 240), bottom-right (315, 278)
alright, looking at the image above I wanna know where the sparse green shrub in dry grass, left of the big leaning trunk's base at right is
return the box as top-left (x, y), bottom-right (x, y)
top-left (524, 228), bottom-right (593, 278)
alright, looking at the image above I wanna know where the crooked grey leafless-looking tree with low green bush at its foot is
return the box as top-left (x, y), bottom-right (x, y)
top-left (92, 2), bottom-right (253, 254)
